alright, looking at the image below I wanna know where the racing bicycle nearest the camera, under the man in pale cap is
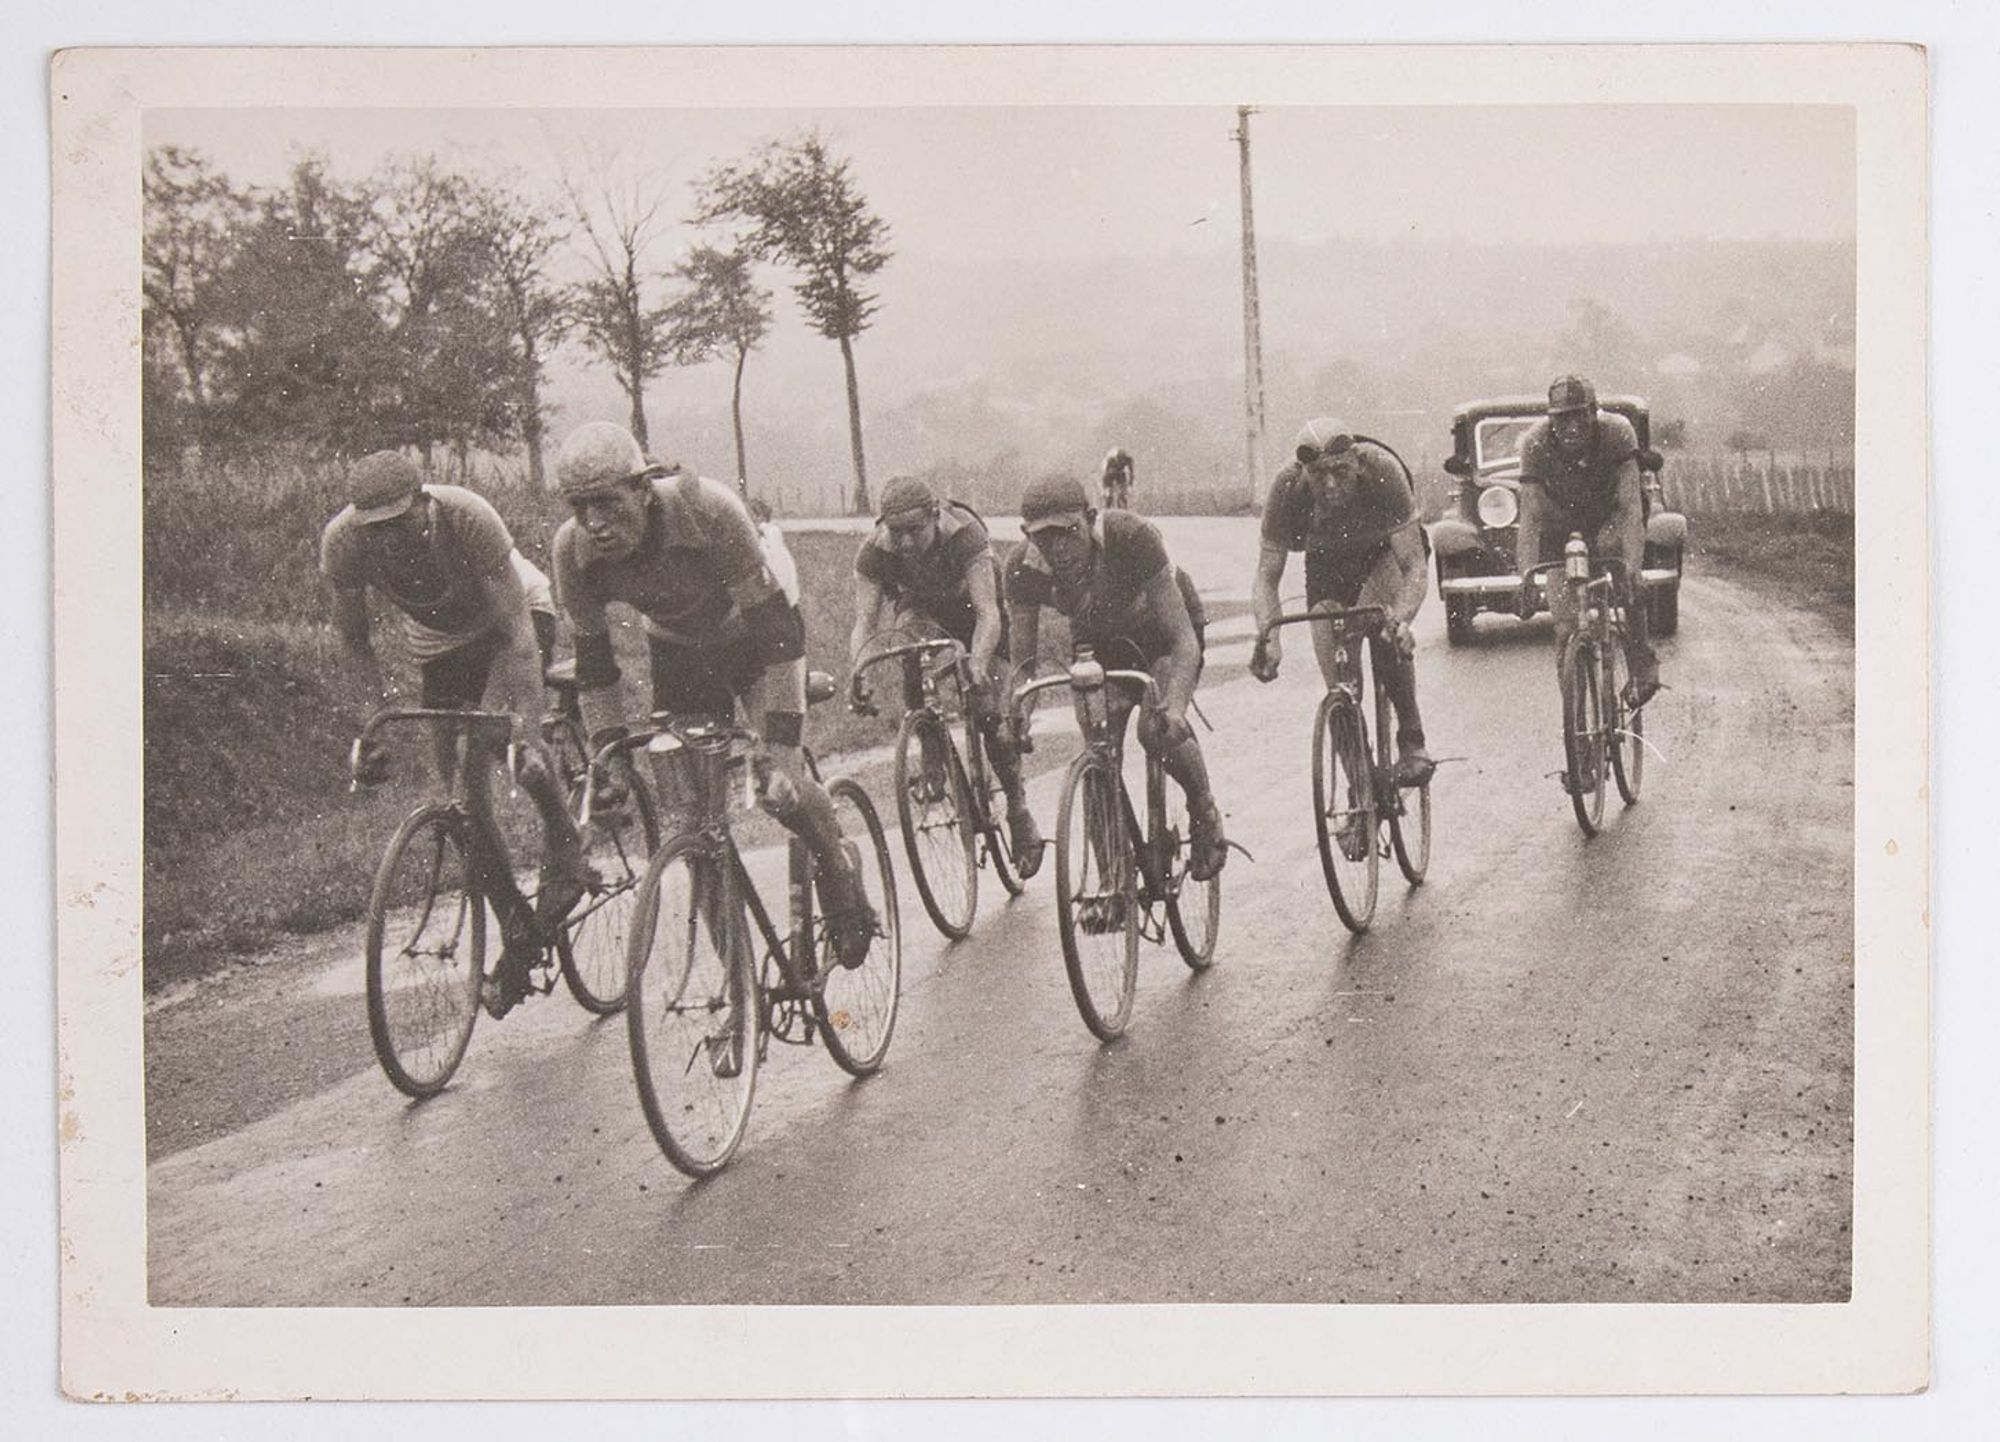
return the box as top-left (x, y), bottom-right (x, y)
top-left (598, 672), bottom-right (902, 1178)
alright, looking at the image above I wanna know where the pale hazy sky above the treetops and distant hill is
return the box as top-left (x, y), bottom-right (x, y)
top-left (146, 106), bottom-right (1854, 258)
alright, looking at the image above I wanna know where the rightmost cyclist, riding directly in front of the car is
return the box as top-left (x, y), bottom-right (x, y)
top-left (1516, 376), bottom-right (1660, 708)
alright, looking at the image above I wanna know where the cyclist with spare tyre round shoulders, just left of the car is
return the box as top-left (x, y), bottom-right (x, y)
top-left (1250, 416), bottom-right (1436, 786)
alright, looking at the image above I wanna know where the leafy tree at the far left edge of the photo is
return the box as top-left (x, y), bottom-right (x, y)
top-left (140, 146), bottom-right (254, 444)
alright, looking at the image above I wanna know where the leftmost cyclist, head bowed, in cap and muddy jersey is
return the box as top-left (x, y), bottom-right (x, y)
top-left (320, 450), bottom-right (596, 1016)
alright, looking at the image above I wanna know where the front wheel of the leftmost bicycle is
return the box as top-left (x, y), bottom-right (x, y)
top-left (366, 804), bottom-right (486, 1096)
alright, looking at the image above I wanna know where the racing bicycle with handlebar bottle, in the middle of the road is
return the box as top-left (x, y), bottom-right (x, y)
top-left (1014, 648), bottom-right (1222, 1042)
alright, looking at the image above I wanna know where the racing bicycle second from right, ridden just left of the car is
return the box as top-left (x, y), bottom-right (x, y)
top-left (1258, 606), bottom-right (1430, 936)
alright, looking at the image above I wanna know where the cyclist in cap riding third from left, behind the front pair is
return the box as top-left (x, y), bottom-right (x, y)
top-left (848, 476), bottom-right (1042, 878)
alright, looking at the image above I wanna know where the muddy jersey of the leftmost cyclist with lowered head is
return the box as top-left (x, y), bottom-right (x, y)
top-left (320, 486), bottom-right (514, 660)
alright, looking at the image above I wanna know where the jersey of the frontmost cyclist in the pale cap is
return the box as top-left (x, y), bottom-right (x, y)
top-left (550, 472), bottom-right (780, 648)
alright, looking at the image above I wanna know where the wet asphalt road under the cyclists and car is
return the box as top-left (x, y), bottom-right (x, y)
top-left (148, 520), bottom-right (1854, 1306)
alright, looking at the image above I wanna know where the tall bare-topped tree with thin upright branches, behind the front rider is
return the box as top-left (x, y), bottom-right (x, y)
top-left (562, 166), bottom-right (668, 448)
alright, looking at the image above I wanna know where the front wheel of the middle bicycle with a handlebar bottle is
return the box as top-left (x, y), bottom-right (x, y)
top-left (1056, 752), bottom-right (1138, 1042)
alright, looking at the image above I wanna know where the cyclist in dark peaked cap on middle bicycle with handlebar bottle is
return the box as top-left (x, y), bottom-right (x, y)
top-left (1006, 476), bottom-right (1228, 882)
